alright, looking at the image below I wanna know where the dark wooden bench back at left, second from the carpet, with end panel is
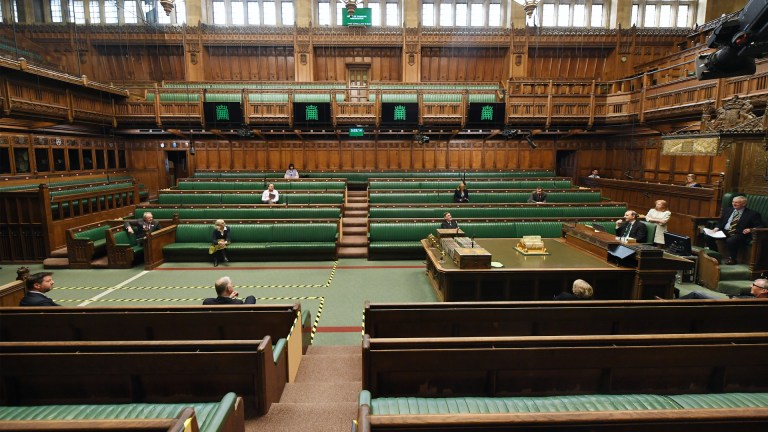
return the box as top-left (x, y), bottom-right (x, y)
top-left (0, 336), bottom-right (287, 416)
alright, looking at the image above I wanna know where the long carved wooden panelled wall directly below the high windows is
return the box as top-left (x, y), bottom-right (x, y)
top-left (14, 25), bottom-right (691, 83)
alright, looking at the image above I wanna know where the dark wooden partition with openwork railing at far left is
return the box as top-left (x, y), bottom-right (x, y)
top-left (0, 181), bottom-right (139, 262)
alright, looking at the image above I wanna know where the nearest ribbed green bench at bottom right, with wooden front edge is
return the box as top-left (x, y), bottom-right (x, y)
top-left (357, 390), bottom-right (768, 432)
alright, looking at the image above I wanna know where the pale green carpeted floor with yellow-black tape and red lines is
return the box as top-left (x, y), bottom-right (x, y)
top-left (0, 259), bottom-right (436, 345)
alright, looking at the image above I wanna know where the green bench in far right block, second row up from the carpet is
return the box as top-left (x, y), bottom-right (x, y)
top-left (368, 205), bottom-right (627, 219)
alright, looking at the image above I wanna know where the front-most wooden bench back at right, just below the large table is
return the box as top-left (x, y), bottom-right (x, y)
top-left (365, 299), bottom-right (768, 338)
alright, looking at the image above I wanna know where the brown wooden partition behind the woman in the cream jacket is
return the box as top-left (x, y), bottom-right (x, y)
top-left (581, 178), bottom-right (723, 239)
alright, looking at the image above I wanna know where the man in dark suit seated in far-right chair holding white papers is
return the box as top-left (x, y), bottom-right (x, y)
top-left (707, 196), bottom-right (763, 265)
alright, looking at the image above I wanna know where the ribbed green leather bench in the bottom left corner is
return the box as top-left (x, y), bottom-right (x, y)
top-left (0, 393), bottom-right (244, 432)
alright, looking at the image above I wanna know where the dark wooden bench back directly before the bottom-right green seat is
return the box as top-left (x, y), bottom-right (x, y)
top-left (363, 333), bottom-right (768, 397)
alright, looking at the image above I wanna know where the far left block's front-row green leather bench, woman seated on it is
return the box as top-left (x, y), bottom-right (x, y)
top-left (160, 221), bottom-right (338, 261)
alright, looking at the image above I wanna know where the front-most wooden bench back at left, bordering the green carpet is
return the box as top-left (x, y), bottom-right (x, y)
top-left (0, 304), bottom-right (301, 342)
